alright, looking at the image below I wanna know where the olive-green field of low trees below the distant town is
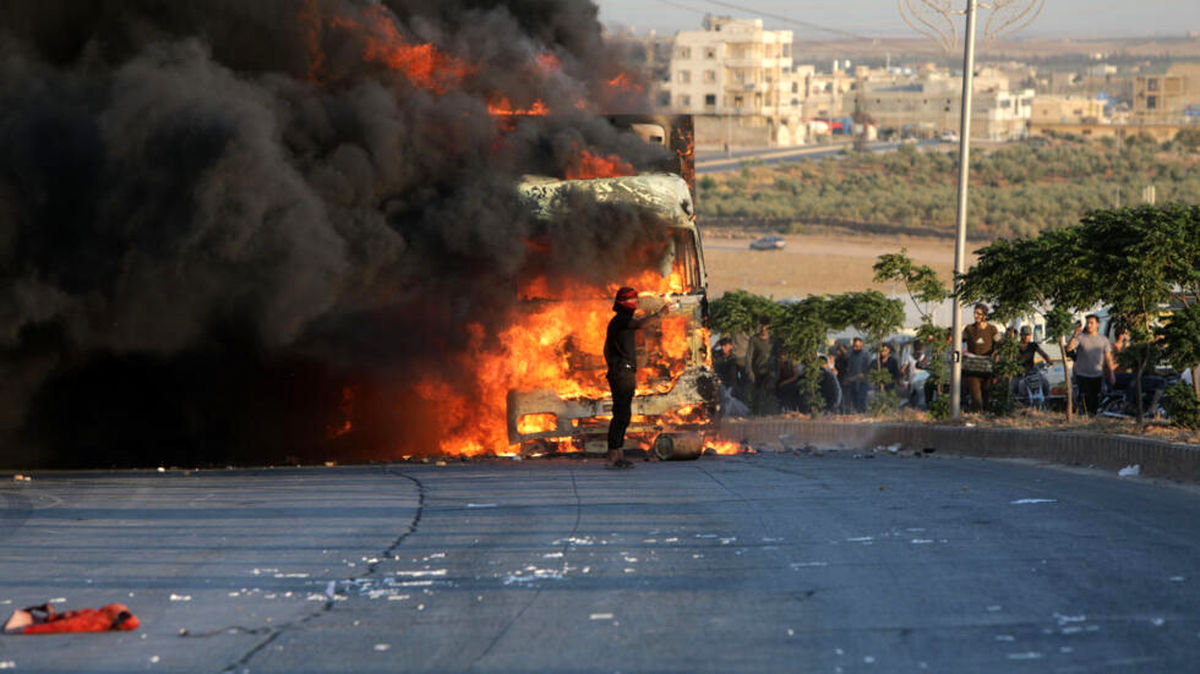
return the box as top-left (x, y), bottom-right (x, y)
top-left (697, 130), bottom-right (1200, 240)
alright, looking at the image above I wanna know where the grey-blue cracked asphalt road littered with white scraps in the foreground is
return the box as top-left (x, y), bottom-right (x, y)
top-left (0, 451), bottom-right (1200, 673)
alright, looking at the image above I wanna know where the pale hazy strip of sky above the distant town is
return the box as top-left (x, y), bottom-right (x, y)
top-left (593, 0), bottom-right (1200, 38)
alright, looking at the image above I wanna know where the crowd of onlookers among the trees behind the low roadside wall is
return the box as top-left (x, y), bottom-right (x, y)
top-left (713, 303), bottom-right (1180, 416)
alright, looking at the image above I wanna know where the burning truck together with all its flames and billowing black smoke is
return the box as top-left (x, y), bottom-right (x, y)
top-left (0, 5), bottom-right (728, 467)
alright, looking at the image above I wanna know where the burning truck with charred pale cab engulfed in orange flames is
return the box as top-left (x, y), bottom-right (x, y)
top-left (506, 116), bottom-right (719, 459)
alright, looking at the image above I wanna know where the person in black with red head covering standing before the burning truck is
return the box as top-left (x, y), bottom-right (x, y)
top-left (604, 285), bottom-right (668, 468)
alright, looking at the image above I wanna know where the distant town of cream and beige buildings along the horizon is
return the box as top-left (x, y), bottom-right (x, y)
top-left (611, 16), bottom-right (1200, 150)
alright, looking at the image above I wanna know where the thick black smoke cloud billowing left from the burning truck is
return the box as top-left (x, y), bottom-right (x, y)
top-left (0, 0), bottom-right (654, 465)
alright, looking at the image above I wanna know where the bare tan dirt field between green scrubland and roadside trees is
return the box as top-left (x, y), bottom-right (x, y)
top-left (703, 230), bottom-right (964, 299)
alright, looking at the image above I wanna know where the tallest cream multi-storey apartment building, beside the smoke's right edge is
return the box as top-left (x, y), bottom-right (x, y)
top-left (656, 17), bottom-right (803, 145)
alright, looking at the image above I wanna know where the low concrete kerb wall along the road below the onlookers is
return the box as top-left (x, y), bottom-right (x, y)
top-left (720, 419), bottom-right (1200, 482)
